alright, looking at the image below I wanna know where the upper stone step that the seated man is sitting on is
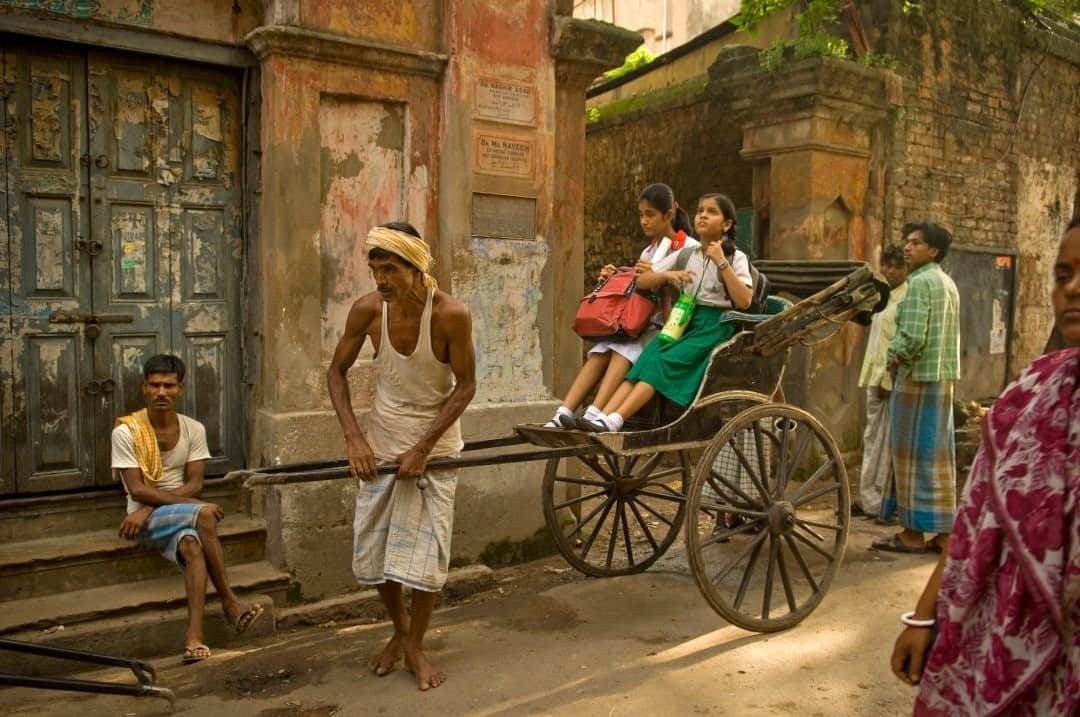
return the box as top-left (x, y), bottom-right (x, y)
top-left (0, 514), bottom-right (266, 609)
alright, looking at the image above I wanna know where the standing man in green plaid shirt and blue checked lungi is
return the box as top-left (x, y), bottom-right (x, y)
top-left (874, 224), bottom-right (960, 553)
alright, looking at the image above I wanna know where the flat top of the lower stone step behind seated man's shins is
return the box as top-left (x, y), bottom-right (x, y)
top-left (0, 560), bottom-right (292, 634)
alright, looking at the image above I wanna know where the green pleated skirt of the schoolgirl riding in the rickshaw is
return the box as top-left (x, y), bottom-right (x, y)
top-left (626, 305), bottom-right (735, 406)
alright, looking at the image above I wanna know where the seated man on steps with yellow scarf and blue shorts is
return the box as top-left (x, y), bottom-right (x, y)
top-left (112, 354), bottom-right (262, 663)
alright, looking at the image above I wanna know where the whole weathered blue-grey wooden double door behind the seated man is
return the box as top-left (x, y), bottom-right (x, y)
top-left (0, 41), bottom-right (243, 495)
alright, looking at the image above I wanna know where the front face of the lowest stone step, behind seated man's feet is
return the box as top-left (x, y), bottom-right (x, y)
top-left (0, 591), bottom-right (278, 678)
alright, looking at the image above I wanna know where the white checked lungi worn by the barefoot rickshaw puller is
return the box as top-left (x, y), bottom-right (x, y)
top-left (352, 471), bottom-right (458, 593)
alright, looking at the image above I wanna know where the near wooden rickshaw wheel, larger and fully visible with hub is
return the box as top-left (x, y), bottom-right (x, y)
top-left (686, 404), bottom-right (850, 632)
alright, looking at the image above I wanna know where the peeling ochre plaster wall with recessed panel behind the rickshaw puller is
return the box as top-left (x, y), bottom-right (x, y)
top-left (253, 56), bottom-right (438, 425)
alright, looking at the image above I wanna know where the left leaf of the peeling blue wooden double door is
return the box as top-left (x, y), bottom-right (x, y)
top-left (3, 44), bottom-right (94, 491)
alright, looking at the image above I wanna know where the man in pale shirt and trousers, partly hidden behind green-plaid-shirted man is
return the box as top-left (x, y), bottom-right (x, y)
top-left (852, 244), bottom-right (907, 523)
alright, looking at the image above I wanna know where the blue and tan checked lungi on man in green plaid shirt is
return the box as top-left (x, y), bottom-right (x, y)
top-left (880, 378), bottom-right (956, 532)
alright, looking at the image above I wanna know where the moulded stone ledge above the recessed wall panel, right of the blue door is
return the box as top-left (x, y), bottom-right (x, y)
top-left (244, 25), bottom-right (448, 79)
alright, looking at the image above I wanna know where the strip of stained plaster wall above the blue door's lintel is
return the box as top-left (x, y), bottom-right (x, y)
top-left (0, 0), bottom-right (262, 44)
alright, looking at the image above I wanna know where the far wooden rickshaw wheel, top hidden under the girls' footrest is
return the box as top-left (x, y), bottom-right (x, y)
top-left (541, 449), bottom-right (691, 578)
